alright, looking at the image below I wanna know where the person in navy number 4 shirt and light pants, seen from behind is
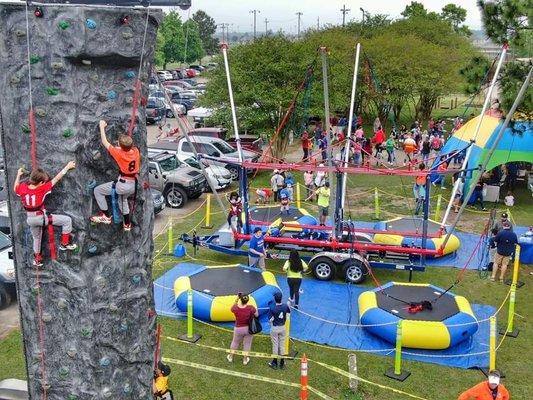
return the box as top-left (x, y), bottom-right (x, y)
top-left (268, 292), bottom-right (291, 369)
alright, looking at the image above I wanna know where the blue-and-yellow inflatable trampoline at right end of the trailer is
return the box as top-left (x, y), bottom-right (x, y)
top-left (374, 217), bottom-right (460, 257)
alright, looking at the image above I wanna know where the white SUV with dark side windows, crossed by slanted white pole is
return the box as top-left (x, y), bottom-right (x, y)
top-left (178, 136), bottom-right (259, 181)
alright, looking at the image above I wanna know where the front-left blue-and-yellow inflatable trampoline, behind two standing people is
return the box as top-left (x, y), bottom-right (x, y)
top-left (174, 265), bottom-right (280, 322)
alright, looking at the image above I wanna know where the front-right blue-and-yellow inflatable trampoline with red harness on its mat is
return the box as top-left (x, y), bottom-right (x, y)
top-left (358, 282), bottom-right (478, 350)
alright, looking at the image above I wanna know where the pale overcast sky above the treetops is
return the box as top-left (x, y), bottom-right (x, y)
top-left (175, 0), bottom-right (481, 33)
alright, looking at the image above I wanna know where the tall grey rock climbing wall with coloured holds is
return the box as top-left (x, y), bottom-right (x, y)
top-left (0, 2), bottom-right (161, 400)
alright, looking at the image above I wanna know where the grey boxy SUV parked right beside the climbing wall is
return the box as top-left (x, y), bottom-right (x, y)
top-left (148, 152), bottom-right (206, 208)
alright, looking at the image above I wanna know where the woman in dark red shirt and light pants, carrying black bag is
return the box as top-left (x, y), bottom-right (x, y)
top-left (227, 293), bottom-right (259, 365)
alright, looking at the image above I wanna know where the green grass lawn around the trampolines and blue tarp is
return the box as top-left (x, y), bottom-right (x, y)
top-left (0, 173), bottom-right (533, 400)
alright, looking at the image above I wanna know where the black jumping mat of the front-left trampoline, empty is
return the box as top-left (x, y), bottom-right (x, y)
top-left (190, 267), bottom-right (265, 296)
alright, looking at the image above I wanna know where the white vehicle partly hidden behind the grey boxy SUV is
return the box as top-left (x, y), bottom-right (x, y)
top-left (148, 145), bottom-right (231, 190)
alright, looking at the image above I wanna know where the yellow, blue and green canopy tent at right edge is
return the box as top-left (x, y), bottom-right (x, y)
top-left (442, 115), bottom-right (533, 191)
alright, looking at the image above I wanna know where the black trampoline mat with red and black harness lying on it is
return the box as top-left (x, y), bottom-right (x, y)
top-left (376, 285), bottom-right (459, 321)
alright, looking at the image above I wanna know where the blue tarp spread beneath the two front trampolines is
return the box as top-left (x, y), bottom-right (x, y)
top-left (154, 263), bottom-right (495, 368)
